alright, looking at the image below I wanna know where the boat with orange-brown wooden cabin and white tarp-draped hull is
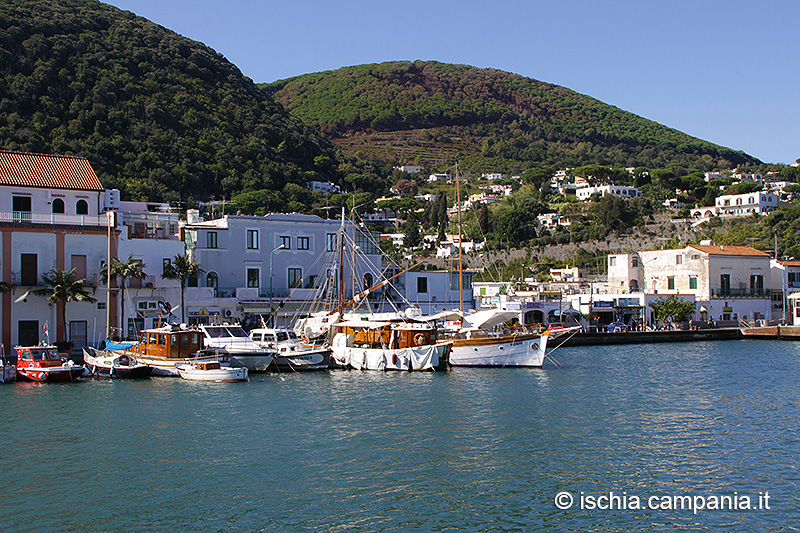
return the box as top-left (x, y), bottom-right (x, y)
top-left (331, 320), bottom-right (452, 370)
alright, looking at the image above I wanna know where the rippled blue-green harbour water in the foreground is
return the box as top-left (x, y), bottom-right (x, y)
top-left (0, 341), bottom-right (800, 532)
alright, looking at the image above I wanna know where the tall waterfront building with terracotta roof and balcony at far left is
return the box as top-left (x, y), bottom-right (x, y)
top-left (0, 151), bottom-right (109, 351)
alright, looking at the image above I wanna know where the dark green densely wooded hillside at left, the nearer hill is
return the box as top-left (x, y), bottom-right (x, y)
top-left (0, 0), bottom-right (337, 200)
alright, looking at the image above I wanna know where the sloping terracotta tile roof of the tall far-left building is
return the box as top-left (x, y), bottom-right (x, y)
top-left (0, 150), bottom-right (103, 191)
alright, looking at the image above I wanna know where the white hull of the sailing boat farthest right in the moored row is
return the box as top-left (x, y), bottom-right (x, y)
top-left (450, 334), bottom-right (547, 368)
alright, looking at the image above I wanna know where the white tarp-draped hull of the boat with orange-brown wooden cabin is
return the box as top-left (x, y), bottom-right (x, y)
top-left (331, 333), bottom-right (450, 370)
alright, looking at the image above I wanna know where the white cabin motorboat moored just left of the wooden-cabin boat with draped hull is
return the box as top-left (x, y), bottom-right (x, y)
top-left (250, 328), bottom-right (331, 371)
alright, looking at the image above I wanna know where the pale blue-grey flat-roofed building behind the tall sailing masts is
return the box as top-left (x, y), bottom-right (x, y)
top-left (186, 213), bottom-right (382, 325)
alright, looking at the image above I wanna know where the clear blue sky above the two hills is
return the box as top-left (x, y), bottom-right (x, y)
top-left (106, 0), bottom-right (800, 163)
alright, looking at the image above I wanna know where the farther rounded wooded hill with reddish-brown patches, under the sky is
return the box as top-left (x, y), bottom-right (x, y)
top-left (262, 61), bottom-right (760, 172)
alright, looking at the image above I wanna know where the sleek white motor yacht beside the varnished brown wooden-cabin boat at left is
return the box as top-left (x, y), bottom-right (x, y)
top-left (200, 324), bottom-right (276, 372)
